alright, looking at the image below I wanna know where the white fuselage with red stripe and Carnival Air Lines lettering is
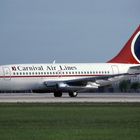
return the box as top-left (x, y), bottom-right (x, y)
top-left (0, 63), bottom-right (135, 91)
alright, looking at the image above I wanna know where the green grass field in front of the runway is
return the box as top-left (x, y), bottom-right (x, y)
top-left (0, 103), bottom-right (140, 140)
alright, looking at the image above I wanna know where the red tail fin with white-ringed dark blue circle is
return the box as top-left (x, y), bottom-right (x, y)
top-left (108, 26), bottom-right (140, 64)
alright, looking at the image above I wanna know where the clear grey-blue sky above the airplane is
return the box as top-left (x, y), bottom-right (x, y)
top-left (0, 0), bottom-right (140, 65)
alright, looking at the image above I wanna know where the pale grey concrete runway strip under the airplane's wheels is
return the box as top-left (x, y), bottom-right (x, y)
top-left (0, 93), bottom-right (140, 103)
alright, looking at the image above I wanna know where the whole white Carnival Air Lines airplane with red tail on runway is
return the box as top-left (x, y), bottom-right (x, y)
top-left (0, 26), bottom-right (140, 97)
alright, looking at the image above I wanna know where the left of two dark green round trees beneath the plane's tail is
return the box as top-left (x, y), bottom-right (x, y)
top-left (119, 80), bottom-right (130, 92)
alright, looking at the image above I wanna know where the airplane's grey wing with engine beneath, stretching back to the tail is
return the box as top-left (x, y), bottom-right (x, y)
top-left (44, 65), bottom-right (140, 92)
